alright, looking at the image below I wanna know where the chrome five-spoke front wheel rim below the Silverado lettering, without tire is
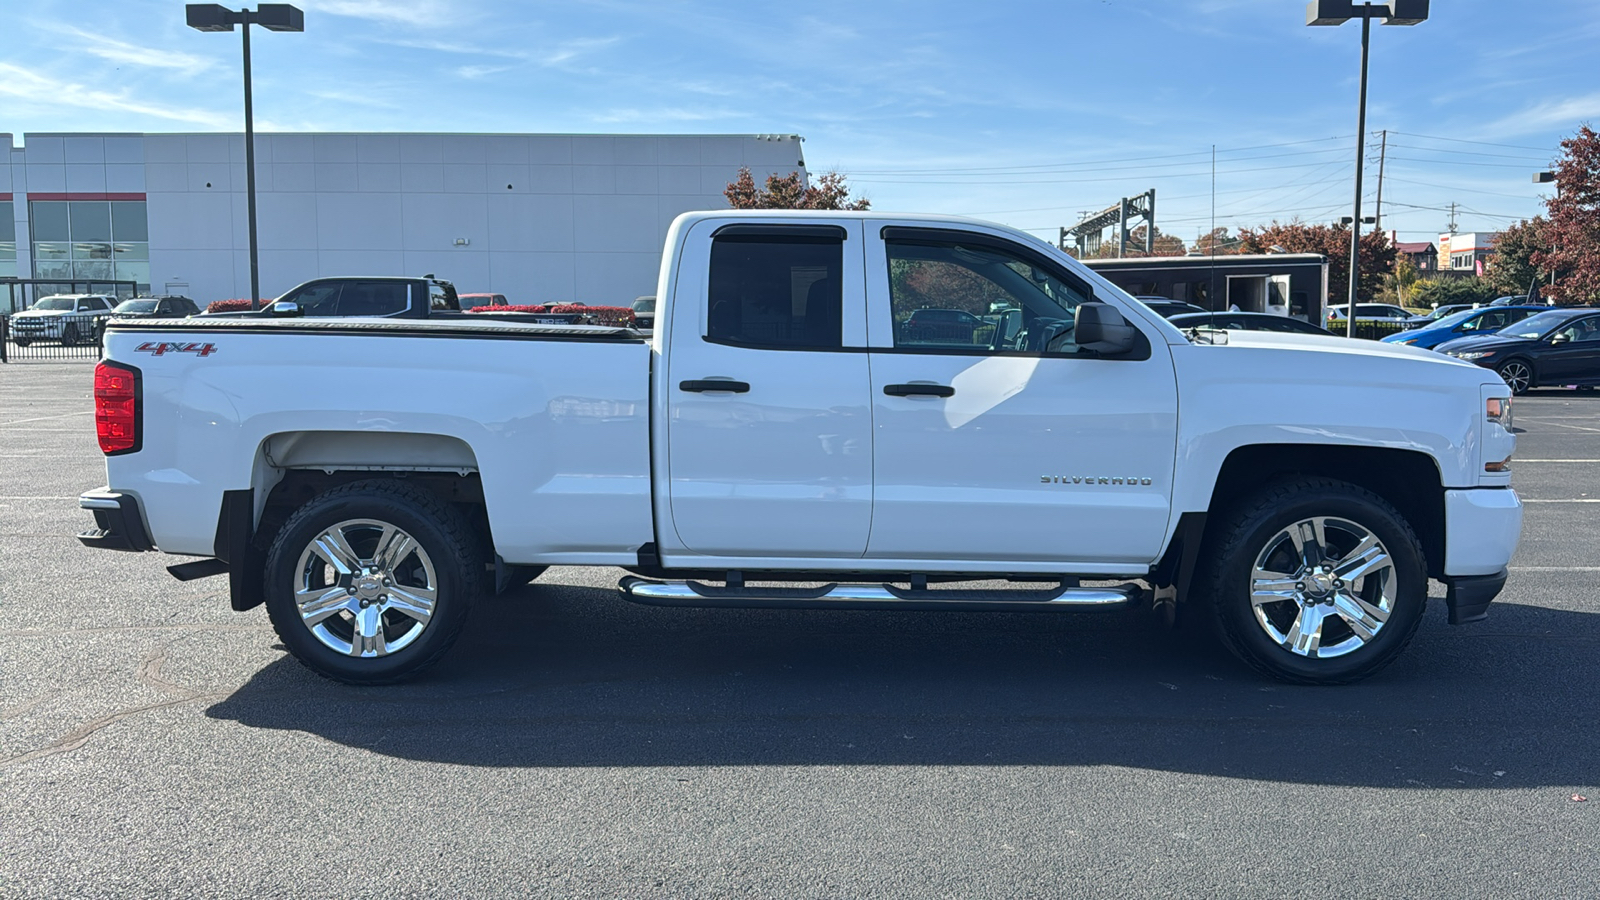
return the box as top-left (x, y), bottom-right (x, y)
top-left (1250, 516), bottom-right (1398, 658)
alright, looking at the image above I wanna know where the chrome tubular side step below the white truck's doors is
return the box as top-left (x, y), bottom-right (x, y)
top-left (618, 575), bottom-right (1144, 612)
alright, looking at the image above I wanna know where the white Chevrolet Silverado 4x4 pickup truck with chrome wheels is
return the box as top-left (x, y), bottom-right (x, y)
top-left (80, 211), bottom-right (1522, 684)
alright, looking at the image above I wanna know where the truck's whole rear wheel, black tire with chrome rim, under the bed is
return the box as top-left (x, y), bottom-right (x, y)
top-left (266, 480), bottom-right (485, 684)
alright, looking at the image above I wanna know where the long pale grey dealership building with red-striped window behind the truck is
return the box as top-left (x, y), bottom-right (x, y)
top-left (0, 133), bottom-right (805, 312)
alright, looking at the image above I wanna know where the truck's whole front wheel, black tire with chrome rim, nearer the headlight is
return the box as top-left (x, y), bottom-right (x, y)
top-left (1195, 477), bottom-right (1427, 684)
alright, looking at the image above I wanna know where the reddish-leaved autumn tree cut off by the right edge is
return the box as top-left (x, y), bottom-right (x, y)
top-left (1523, 125), bottom-right (1600, 306)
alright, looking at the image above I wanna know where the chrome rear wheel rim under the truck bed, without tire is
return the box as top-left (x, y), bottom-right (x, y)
top-left (294, 519), bottom-right (438, 657)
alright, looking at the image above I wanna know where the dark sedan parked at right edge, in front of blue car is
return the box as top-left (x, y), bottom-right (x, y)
top-left (1434, 307), bottom-right (1600, 394)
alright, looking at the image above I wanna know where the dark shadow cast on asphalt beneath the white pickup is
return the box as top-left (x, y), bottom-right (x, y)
top-left (206, 583), bottom-right (1600, 790)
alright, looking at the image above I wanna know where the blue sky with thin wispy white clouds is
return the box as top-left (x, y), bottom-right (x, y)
top-left (0, 0), bottom-right (1600, 240)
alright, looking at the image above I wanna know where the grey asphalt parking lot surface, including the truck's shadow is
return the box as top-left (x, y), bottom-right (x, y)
top-left (0, 364), bottom-right (1600, 898)
